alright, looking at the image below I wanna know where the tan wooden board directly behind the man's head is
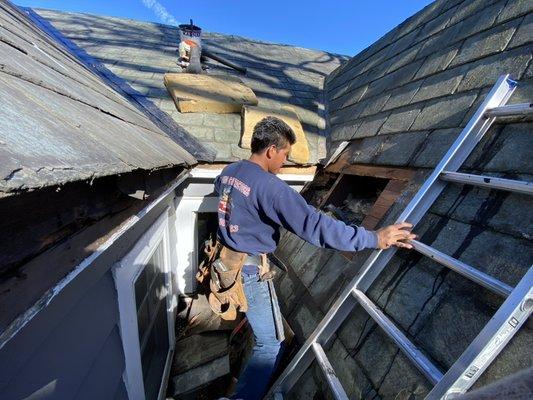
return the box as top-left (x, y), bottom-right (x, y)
top-left (239, 106), bottom-right (309, 164)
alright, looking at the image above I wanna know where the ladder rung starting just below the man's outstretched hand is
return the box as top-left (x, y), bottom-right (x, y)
top-left (409, 240), bottom-right (513, 297)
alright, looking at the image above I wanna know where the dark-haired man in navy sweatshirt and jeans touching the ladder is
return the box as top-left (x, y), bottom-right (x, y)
top-left (215, 117), bottom-right (415, 400)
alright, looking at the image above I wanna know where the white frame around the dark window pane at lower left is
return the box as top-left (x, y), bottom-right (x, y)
top-left (112, 207), bottom-right (175, 400)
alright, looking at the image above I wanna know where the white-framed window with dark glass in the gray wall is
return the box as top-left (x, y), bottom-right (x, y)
top-left (113, 211), bottom-right (174, 400)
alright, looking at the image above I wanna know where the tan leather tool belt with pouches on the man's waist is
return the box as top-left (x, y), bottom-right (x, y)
top-left (196, 240), bottom-right (273, 321)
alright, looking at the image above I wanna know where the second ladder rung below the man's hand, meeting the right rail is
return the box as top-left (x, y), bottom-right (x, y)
top-left (352, 289), bottom-right (443, 385)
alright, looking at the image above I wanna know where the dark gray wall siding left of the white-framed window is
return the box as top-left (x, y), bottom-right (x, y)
top-left (0, 272), bottom-right (124, 400)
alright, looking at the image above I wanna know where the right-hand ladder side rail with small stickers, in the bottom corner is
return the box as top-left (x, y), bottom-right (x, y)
top-left (426, 266), bottom-right (533, 400)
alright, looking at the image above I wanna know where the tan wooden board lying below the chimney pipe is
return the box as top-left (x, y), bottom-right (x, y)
top-left (164, 73), bottom-right (257, 114)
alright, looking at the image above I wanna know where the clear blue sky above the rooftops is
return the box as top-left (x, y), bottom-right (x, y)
top-left (12, 0), bottom-right (431, 55)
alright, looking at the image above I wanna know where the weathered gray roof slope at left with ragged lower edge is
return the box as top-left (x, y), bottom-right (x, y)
top-left (0, 1), bottom-right (201, 197)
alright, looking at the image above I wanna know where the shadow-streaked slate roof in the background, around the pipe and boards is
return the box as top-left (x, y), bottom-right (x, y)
top-left (35, 9), bottom-right (348, 163)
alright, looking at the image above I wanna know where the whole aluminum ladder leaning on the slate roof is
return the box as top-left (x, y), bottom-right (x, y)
top-left (267, 75), bottom-right (533, 400)
